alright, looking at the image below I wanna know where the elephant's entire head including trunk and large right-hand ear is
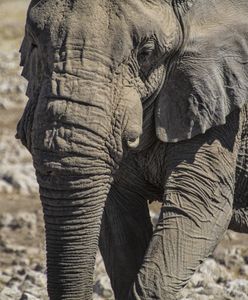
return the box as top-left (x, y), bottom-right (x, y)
top-left (17, 0), bottom-right (248, 300)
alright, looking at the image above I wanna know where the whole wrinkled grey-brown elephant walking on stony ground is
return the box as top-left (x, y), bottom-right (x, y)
top-left (17, 0), bottom-right (248, 300)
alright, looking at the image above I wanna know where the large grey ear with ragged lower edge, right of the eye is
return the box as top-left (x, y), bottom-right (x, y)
top-left (155, 0), bottom-right (248, 142)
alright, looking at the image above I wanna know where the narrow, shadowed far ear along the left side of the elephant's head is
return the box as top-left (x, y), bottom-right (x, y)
top-left (16, 29), bottom-right (43, 150)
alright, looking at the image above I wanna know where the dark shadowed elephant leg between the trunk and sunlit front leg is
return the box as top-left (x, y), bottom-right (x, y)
top-left (100, 184), bottom-right (152, 300)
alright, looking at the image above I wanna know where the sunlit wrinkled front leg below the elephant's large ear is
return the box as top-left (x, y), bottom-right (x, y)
top-left (128, 113), bottom-right (241, 300)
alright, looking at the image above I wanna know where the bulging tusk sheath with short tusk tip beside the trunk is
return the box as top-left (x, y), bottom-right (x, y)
top-left (122, 87), bottom-right (143, 149)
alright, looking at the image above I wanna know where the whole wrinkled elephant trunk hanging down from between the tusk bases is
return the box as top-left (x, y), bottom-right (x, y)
top-left (31, 65), bottom-right (122, 300)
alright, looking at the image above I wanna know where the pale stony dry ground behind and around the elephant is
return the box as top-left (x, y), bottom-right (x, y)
top-left (0, 0), bottom-right (248, 300)
